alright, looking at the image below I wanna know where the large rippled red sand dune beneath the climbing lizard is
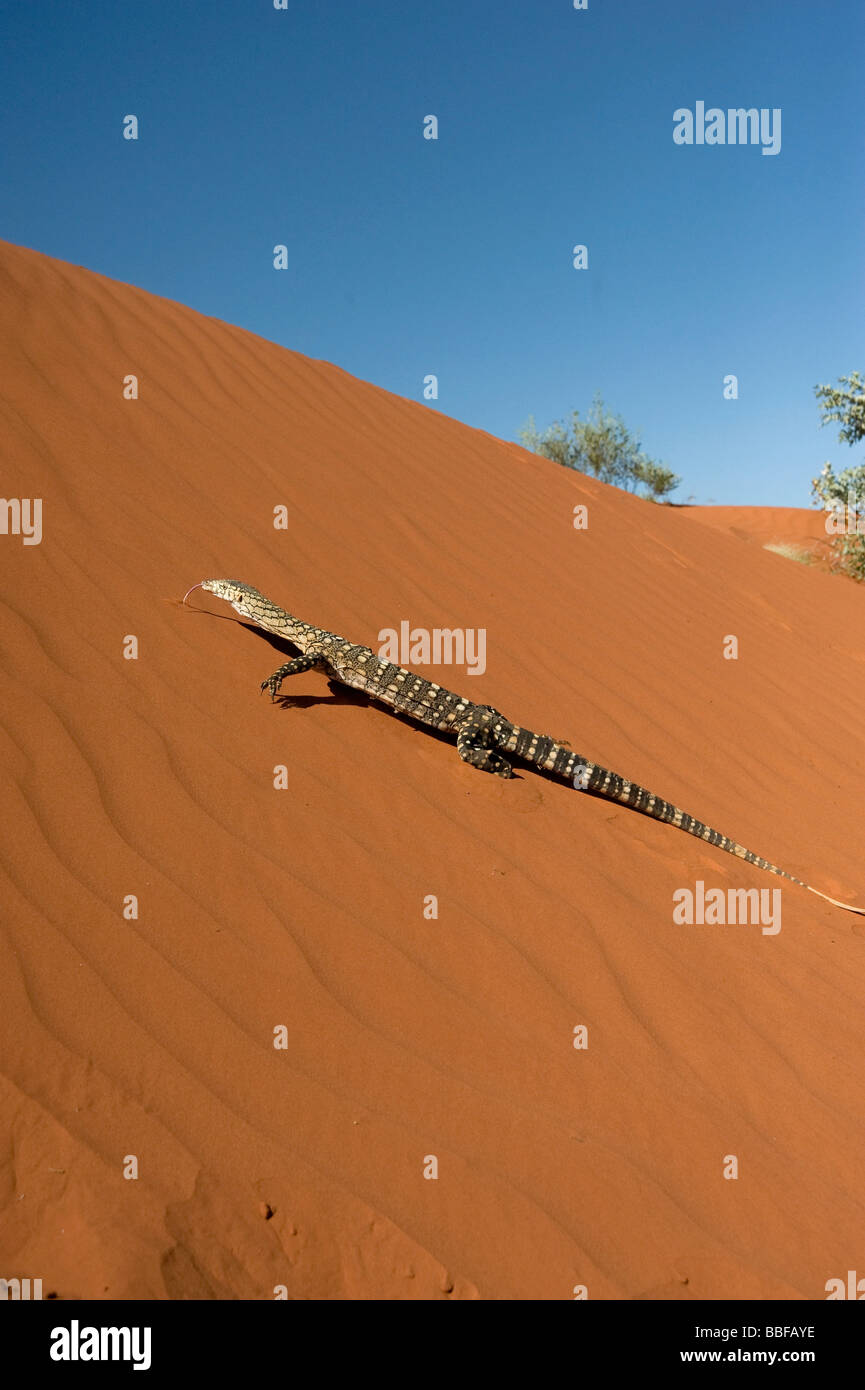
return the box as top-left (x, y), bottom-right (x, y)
top-left (0, 245), bottom-right (865, 1300)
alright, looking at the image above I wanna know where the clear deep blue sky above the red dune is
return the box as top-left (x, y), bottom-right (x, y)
top-left (0, 0), bottom-right (865, 506)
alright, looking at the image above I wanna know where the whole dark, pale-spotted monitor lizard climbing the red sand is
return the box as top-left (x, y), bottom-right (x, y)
top-left (184, 580), bottom-right (865, 916)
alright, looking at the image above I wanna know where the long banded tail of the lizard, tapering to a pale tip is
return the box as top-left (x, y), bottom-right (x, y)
top-left (505, 728), bottom-right (865, 916)
